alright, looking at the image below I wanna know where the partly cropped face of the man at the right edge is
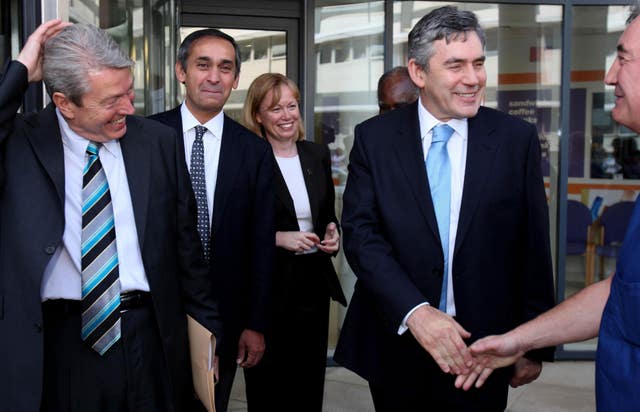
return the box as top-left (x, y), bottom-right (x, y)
top-left (604, 18), bottom-right (640, 132)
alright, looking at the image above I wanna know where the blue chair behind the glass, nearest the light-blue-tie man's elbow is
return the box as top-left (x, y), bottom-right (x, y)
top-left (567, 200), bottom-right (595, 286)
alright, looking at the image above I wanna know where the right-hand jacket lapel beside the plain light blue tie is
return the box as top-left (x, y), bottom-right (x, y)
top-left (453, 107), bottom-right (499, 258)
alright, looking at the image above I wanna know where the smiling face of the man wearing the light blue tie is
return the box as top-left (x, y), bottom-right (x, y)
top-left (409, 31), bottom-right (487, 122)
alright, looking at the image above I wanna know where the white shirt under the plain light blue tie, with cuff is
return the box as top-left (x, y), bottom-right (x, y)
top-left (398, 100), bottom-right (468, 334)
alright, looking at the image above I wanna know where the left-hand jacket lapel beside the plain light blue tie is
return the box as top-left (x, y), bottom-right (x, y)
top-left (389, 102), bottom-right (440, 239)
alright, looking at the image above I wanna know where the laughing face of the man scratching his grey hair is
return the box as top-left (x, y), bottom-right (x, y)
top-left (53, 68), bottom-right (135, 143)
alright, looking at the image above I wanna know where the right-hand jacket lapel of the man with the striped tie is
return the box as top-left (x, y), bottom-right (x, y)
top-left (120, 118), bottom-right (151, 247)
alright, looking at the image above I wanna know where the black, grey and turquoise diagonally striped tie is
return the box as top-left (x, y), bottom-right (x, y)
top-left (82, 142), bottom-right (120, 355)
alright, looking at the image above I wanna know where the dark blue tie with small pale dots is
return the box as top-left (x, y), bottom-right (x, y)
top-left (190, 126), bottom-right (210, 264)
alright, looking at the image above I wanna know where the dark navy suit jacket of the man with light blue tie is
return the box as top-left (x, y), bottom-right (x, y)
top-left (335, 103), bottom-right (554, 390)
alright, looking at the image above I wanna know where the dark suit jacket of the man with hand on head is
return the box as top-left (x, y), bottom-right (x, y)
top-left (0, 62), bottom-right (220, 411)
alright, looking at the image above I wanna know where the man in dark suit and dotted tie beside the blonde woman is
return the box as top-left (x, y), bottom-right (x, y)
top-left (151, 29), bottom-right (275, 412)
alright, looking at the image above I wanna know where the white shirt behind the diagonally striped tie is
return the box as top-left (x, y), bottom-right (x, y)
top-left (40, 109), bottom-right (150, 301)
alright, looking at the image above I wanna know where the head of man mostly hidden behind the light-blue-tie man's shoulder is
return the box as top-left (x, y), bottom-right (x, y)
top-left (378, 66), bottom-right (418, 114)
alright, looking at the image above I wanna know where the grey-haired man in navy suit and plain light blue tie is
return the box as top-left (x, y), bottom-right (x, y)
top-left (335, 7), bottom-right (553, 411)
